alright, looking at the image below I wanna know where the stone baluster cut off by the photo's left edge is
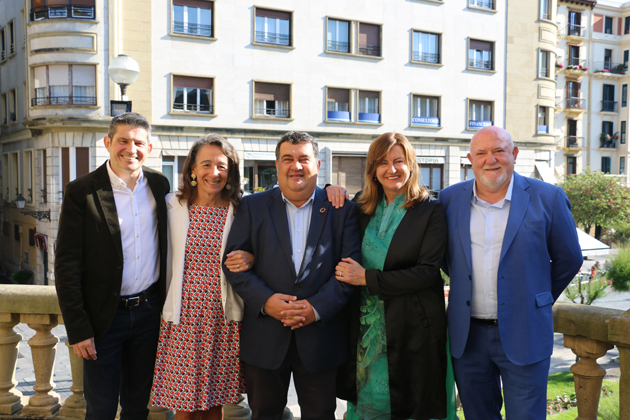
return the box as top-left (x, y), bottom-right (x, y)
top-left (0, 313), bottom-right (22, 415)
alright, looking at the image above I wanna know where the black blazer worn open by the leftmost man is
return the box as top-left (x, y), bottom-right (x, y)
top-left (55, 162), bottom-right (170, 344)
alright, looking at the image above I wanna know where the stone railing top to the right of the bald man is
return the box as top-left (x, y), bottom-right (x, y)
top-left (553, 303), bottom-right (630, 344)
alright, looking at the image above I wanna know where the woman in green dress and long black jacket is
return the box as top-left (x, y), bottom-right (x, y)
top-left (336, 133), bottom-right (456, 420)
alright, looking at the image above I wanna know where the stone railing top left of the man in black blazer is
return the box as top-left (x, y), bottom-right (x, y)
top-left (0, 284), bottom-right (61, 315)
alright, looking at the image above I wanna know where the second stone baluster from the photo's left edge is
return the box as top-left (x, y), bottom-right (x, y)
top-left (22, 314), bottom-right (60, 417)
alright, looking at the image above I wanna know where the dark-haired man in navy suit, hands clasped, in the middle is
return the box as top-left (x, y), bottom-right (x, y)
top-left (224, 132), bottom-right (361, 420)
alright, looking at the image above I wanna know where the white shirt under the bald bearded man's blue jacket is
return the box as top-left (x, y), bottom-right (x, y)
top-left (470, 175), bottom-right (514, 319)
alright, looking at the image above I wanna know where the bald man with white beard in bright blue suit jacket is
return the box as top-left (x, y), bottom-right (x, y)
top-left (440, 127), bottom-right (582, 420)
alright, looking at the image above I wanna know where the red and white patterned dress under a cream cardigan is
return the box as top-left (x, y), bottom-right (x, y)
top-left (151, 206), bottom-right (245, 412)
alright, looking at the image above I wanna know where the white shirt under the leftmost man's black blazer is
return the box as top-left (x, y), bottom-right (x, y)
top-left (103, 162), bottom-right (160, 296)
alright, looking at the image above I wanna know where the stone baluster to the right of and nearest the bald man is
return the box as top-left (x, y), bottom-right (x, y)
top-left (564, 335), bottom-right (613, 420)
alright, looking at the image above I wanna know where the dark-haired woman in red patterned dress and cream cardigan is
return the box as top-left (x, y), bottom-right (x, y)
top-left (152, 134), bottom-right (253, 420)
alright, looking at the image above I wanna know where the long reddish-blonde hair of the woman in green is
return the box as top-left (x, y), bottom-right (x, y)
top-left (358, 133), bottom-right (429, 215)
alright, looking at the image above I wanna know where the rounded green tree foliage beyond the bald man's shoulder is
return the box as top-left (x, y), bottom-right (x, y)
top-left (561, 168), bottom-right (630, 236)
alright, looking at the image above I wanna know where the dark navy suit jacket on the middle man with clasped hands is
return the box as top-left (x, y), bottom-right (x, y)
top-left (223, 188), bottom-right (361, 372)
